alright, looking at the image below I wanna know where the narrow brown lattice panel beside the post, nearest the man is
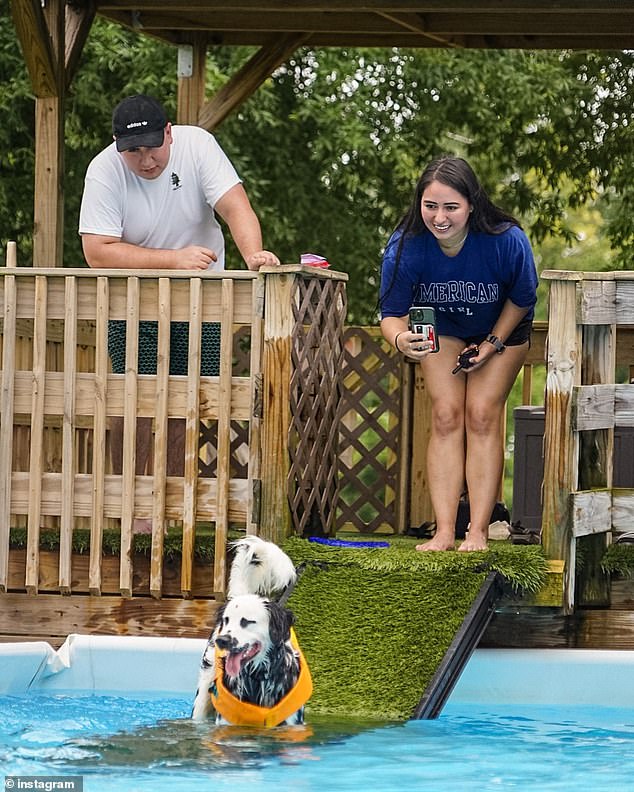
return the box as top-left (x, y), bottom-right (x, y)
top-left (288, 278), bottom-right (346, 535)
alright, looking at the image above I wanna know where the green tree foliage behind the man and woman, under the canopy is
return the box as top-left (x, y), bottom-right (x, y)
top-left (0, 9), bottom-right (634, 324)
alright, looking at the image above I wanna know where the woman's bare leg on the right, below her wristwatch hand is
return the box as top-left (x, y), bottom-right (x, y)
top-left (459, 344), bottom-right (528, 551)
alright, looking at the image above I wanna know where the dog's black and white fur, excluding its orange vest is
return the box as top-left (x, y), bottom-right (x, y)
top-left (192, 536), bottom-right (304, 724)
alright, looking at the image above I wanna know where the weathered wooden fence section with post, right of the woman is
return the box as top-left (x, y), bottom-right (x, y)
top-left (542, 271), bottom-right (634, 611)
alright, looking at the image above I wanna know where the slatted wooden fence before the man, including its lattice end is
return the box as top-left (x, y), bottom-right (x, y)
top-left (0, 251), bottom-right (347, 633)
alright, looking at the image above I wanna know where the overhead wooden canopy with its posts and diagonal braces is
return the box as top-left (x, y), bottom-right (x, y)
top-left (11, 0), bottom-right (634, 266)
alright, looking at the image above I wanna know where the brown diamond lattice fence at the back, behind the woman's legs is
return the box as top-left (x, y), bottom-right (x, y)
top-left (337, 321), bottom-right (634, 552)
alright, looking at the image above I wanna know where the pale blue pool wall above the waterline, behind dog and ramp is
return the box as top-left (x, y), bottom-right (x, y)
top-left (0, 635), bottom-right (634, 707)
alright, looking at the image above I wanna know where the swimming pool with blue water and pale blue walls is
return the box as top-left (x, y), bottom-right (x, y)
top-left (0, 638), bottom-right (634, 792)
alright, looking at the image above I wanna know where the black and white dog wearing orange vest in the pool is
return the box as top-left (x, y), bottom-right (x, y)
top-left (192, 536), bottom-right (312, 727)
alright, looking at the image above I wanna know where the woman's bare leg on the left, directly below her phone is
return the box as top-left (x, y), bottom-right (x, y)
top-left (416, 336), bottom-right (466, 551)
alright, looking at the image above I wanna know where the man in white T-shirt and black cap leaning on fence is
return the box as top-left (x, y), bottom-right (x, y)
top-left (79, 95), bottom-right (280, 532)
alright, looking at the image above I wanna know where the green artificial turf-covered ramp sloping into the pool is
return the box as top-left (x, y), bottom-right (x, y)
top-left (284, 537), bottom-right (547, 721)
